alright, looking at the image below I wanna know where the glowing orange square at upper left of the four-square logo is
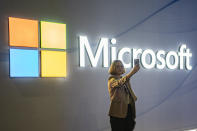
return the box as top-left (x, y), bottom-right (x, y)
top-left (9, 17), bottom-right (38, 48)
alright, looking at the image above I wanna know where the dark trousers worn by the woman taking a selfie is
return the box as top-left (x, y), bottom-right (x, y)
top-left (110, 105), bottom-right (136, 131)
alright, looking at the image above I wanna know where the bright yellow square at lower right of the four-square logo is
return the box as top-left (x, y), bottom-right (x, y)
top-left (41, 50), bottom-right (67, 77)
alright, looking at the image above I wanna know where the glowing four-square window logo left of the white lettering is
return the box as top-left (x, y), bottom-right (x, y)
top-left (9, 17), bottom-right (67, 77)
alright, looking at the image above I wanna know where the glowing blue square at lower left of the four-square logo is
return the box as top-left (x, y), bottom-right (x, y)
top-left (10, 49), bottom-right (39, 77)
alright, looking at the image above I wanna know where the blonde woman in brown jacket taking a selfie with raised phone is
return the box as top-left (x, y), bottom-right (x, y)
top-left (108, 60), bottom-right (140, 131)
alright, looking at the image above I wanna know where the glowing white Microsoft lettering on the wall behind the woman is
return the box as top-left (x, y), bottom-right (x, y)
top-left (79, 36), bottom-right (192, 70)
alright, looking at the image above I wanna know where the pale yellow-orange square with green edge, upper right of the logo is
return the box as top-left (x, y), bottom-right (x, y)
top-left (40, 21), bottom-right (66, 49)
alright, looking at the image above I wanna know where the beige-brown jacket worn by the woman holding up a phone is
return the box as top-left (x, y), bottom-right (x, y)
top-left (108, 76), bottom-right (137, 118)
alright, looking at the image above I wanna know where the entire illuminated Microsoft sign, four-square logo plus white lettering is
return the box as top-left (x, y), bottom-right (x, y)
top-left (9, 17), bottom-right (192, 74)
